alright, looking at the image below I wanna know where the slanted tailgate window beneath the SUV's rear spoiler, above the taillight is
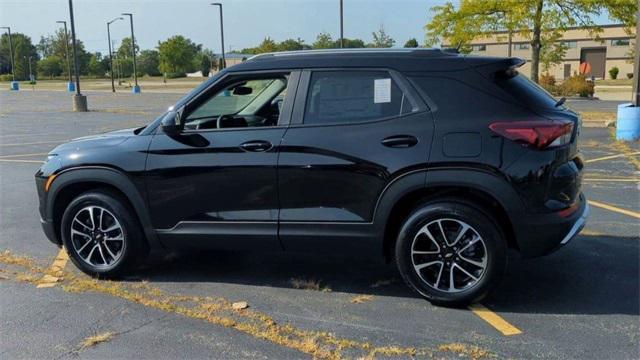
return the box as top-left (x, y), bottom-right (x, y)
top-left (496, 74), bottom-right (557, 108)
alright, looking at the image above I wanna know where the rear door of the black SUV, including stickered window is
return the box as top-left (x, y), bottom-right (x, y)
top-left (278, 69), bottom-right (433, 253)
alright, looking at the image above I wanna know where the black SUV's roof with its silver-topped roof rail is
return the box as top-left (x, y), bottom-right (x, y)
top-left (228, 48), bottom-right (480, 72)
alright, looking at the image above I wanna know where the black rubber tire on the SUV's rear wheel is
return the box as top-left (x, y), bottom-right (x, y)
top-left (395, 198), bottom-right (507, 307)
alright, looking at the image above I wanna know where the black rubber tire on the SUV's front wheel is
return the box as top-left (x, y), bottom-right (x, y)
top-left (60, 189), bottom-right (148, 278)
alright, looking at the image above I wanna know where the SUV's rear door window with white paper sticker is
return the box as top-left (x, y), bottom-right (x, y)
top-left (304, 71), bottom-right (404, 124)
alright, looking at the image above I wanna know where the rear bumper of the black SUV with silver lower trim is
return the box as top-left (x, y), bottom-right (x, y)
top-left (513, 194), bottom-right (589, 258)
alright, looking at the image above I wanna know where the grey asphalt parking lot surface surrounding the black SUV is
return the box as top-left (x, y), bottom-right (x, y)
top-left (0, 91), bottom-right (640, 359)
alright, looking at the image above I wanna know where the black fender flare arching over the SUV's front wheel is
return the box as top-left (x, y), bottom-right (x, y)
top-left (45, 166), bottom-right (163, 250)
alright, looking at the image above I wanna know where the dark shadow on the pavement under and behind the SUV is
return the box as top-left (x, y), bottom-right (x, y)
top-left (132, 235), bottom-right (640, 315)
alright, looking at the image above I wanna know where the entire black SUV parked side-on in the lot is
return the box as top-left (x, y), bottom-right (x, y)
top-left (36, 49), bottom-right (588, 305)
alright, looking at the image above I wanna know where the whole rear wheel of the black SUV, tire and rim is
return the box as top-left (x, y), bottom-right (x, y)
top-left (396, 199), bottom-right (506, 306)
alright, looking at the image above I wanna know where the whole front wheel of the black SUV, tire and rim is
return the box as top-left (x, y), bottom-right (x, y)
top-left (61, 190), bottom-right (145, 278)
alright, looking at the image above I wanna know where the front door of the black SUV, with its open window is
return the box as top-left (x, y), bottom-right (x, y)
top-left (147, 71), bottom-right (299, 250)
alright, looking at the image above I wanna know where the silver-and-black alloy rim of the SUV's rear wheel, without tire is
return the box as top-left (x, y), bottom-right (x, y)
top-left (411, 218), bottom-right (488, 293)
